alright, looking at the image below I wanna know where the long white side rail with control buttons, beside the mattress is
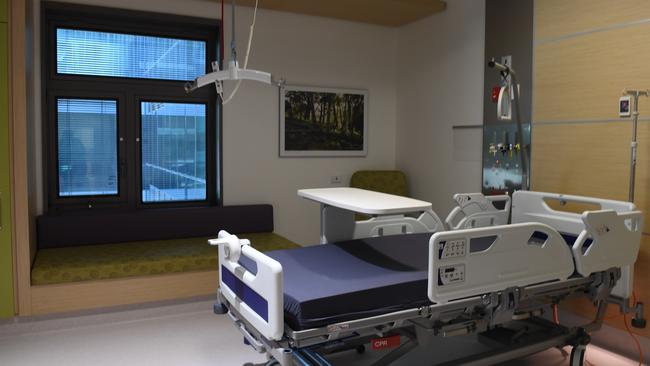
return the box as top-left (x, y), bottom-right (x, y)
top-left (428, 223), bottom-right (574, 303)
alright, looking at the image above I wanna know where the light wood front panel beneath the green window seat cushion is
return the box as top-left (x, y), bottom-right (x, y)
top-left (30, 270), bottom-right (219, 315)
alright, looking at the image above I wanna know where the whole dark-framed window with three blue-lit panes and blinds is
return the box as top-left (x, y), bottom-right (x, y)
top-left (43, 3), bottom-right (221, 210)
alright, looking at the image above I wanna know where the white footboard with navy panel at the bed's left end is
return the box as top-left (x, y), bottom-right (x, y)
top-left (209, 230), bottom-right (284, 340)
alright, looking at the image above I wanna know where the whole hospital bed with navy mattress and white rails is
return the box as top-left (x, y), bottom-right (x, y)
top-left (211, 191), bottom-right (643, 366)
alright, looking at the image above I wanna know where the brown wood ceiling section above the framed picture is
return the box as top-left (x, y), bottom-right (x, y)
top-left (223, 0), bottom-right (447, 27)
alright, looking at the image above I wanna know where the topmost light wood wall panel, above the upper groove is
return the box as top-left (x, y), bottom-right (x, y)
top-left (535, 0), bottom-right (650, 40)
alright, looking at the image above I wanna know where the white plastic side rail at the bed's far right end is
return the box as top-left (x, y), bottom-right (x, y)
top-left (572, 210), bottom-right (643, 298)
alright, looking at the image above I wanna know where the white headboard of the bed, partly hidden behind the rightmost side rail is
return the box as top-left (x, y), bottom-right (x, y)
top-left (512, 191), bottom-right (636, 236)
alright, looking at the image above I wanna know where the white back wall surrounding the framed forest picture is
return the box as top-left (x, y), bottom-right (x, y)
top-left (29, 0), bottom-right (397, 244)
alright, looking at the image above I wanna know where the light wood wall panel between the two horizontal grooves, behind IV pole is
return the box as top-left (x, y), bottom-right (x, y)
top-left (533, 22), bottom-right (650, 122)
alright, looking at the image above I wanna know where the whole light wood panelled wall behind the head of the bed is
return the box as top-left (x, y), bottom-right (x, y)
top-left (531, 0), bottom-right (650, 337)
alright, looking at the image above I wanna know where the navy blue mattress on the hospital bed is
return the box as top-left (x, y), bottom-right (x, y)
top-left (253, 233), bottom-right (431, 330)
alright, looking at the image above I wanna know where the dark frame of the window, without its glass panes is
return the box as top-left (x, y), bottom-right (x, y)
top-left (41, 2), bottom-right (222, 211)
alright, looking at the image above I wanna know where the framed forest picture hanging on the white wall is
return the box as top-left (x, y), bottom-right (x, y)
top-left (280, 86), bottom-right (368, 156)
